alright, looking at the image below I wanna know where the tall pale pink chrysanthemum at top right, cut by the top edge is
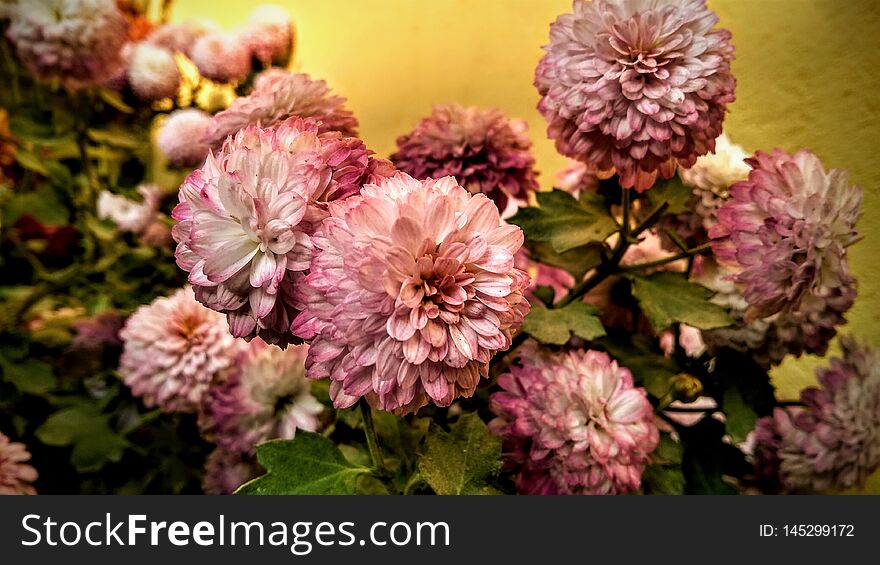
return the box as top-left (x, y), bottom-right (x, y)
top-left (535, 0), bottom-right (735, 191)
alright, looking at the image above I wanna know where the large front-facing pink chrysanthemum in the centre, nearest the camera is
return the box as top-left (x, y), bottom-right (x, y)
top-left (291, 173), bottom-right (529, 414)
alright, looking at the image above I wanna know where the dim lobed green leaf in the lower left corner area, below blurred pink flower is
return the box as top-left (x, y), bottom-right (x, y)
top-left (36, 406), bottom-right (129, 473)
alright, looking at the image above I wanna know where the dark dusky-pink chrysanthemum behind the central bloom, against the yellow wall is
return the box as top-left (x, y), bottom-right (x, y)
top-left (391, 104), bottom-right (538, 212)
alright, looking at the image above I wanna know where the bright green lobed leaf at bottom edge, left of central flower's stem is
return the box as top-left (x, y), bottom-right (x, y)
top-left (235, 431), bottom-right (370, 494)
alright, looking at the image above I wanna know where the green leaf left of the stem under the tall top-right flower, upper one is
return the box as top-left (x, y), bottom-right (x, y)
top-left (510, 190), bottom-right (617, 253)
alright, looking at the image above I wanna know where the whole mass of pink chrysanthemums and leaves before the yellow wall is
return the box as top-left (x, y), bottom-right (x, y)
top-left (0, 0), bottom-right (880, 494)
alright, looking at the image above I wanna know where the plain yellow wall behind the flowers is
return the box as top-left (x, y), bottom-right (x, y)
top-left (174, 0), bottom-right (880, 478)
